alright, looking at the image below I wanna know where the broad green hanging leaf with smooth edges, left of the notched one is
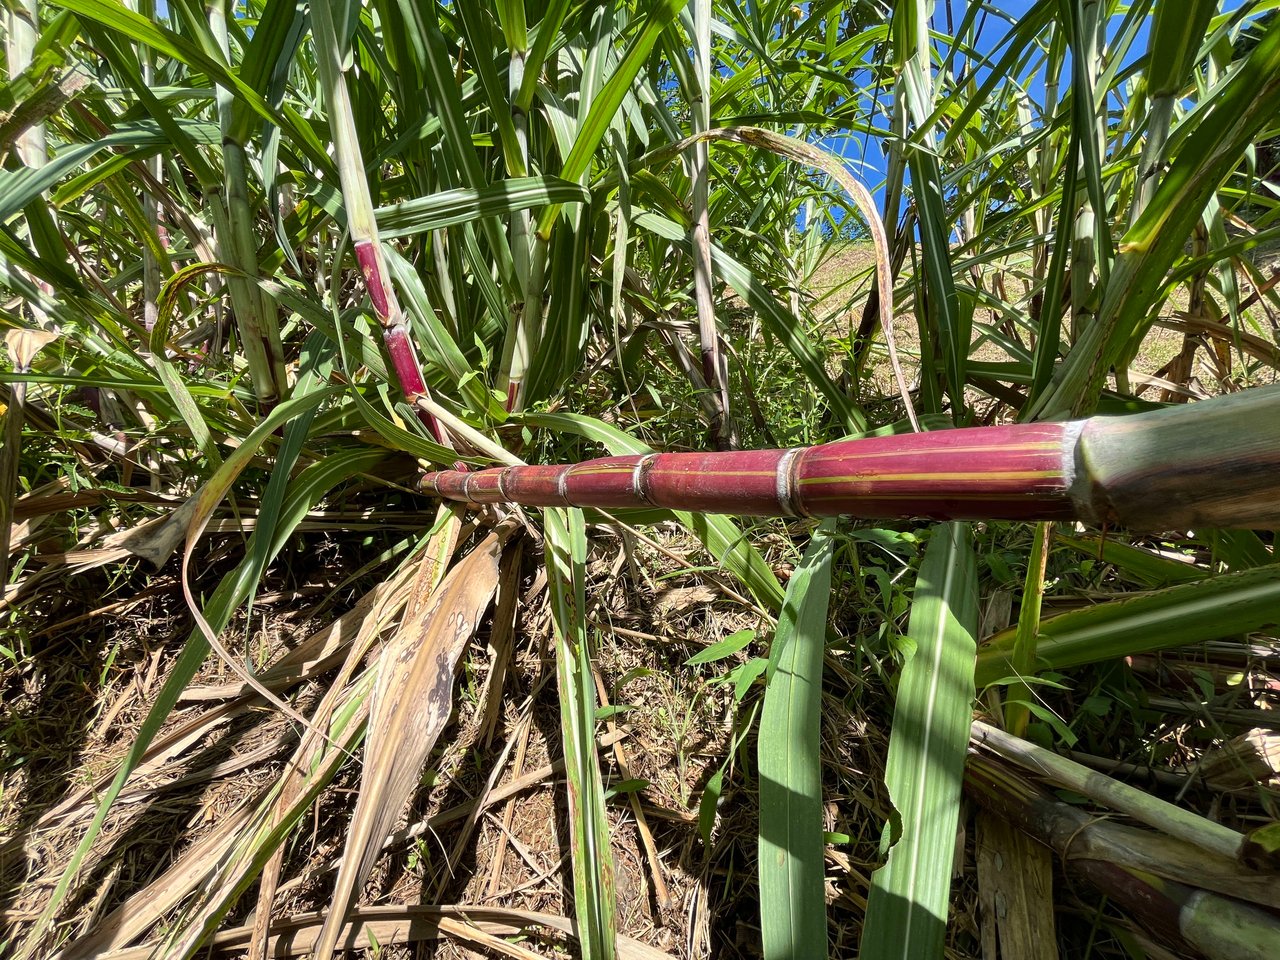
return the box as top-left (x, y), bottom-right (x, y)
top-left (758, 520), bottom-right (836, 960)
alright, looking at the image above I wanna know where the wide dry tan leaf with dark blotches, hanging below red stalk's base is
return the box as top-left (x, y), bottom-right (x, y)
top-left (315, 534), bottom-right (504, 957)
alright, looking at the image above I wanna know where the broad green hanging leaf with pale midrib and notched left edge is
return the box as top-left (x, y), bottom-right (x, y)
top-left (860, 524), bottom-right (978, 960)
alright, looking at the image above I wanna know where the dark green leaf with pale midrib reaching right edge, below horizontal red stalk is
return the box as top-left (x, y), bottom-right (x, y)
top-left (975, 563), bottom-right (1280, 686)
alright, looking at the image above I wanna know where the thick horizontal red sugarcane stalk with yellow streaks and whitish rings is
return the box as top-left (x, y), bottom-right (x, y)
top-left (422, 388), bottom-right (1280, 531)
